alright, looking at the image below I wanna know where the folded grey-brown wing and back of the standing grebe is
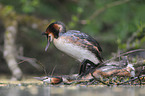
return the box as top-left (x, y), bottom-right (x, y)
top-left (62, 32), bottom-right (103, 62)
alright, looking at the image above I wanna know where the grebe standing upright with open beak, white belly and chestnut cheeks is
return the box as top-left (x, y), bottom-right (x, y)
top-left (42, 21), bottom-right (103, 75)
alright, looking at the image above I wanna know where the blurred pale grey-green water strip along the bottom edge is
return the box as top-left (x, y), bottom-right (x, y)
top-left (0, 86), bottom-right (145, 96)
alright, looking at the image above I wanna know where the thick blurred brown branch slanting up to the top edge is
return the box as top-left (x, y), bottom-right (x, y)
top-left (89, 0), bottom-right (130, 20)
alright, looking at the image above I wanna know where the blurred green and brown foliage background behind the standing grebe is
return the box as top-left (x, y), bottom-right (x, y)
top-left (0, 0), bottom-right (145, 75)
